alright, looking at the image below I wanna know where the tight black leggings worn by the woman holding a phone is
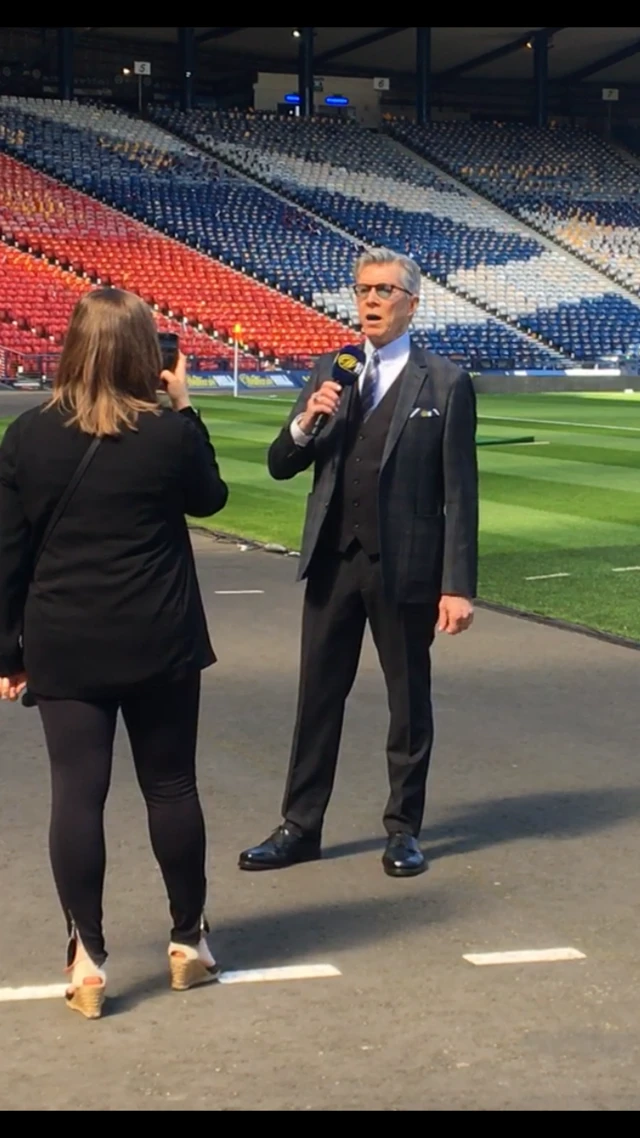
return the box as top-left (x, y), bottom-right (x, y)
top-left (38, 673), bottom-right (206, 966)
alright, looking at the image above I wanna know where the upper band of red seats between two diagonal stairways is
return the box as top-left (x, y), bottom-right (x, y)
top-left (0, 144), bottom-right (344, 357)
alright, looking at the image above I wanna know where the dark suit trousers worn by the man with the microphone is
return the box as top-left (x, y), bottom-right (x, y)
top-left (282, 546), bottom-right (437, 838)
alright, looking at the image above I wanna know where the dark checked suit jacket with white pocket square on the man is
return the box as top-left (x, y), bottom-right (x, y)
top-left (268, 345), bottom-right (478, 604)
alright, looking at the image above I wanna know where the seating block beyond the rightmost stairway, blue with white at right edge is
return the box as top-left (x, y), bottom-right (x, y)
top-left (387, 119), bottom-right (640, 292)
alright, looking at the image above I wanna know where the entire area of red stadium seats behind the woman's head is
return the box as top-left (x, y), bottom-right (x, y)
top-left (0, 155), bottom-right (345, 357)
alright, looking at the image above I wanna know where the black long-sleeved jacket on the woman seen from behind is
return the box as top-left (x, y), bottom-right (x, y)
top-left (0, 407), bottom-right (228, 699)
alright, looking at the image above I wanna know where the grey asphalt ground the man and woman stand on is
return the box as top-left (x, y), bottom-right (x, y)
top-left (0, 393), bottom-right (640, 1111)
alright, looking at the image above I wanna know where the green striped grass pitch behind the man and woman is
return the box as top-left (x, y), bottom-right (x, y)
top-left (0, 394), bottom-right (640, 641)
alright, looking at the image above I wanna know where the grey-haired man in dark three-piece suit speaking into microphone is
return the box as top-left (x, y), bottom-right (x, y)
top-left (239, 249), bottom-right (478, 877)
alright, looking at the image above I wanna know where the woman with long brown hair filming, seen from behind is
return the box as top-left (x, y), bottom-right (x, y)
top-left (0, 289), bottom-right (228, 1019)
